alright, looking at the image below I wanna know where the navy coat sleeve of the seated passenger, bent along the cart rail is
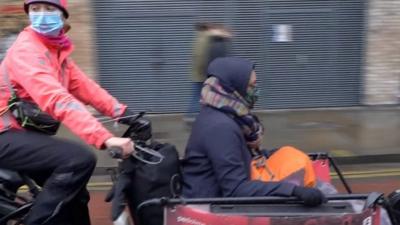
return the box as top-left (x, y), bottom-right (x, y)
top-left (204, 124), bottom-right (294, 197)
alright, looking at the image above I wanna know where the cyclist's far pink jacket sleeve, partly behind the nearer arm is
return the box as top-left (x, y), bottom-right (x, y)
top-left (67, 59), bottom-right (126, 118)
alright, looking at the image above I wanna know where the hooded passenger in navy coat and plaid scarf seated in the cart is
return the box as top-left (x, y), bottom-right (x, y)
top-left (183, 57), bottom-right (325, 206)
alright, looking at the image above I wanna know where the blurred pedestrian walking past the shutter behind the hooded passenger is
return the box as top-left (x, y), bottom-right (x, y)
top-left (185, 23), bottom-right (232, 123)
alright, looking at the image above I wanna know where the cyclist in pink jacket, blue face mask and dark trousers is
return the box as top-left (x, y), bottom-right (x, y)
top-left (0, 0), bottom-right (134, 225)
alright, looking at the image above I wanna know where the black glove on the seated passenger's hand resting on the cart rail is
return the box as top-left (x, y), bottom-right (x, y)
top-left (293, 186), bottom-right (326, 206)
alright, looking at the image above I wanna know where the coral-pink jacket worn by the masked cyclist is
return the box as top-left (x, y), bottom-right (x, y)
top-left (0, 27), bottom-right (126, 148)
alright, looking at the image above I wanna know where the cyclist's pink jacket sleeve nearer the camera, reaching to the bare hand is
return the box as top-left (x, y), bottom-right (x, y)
top-left (8, 49), bottom-right (113, 148)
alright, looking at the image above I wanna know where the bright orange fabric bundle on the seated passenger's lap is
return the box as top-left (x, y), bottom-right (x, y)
top-left (250, 146), bottom-right (316, 187)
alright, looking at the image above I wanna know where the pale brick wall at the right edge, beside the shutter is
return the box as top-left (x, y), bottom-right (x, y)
top-left (363, 0), bottom-right (400, 105)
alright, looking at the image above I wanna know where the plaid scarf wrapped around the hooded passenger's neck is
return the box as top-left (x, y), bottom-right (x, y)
top-left (200, 77), bottom-right (264, 148)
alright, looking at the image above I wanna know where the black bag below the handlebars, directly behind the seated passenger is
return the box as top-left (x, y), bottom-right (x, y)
top-left (106, 143), bottom-right (181, 225)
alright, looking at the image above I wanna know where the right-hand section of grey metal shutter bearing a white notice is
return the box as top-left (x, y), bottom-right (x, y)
top-left (262, 0), bottom-right (363, 108)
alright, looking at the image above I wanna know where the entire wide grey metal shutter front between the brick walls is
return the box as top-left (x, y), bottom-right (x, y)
top-left (93, 0), bottom-right (364, 113)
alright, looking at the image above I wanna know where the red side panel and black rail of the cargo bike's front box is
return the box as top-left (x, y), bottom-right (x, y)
top-left (137, 192), bottom-right (398, 225)
